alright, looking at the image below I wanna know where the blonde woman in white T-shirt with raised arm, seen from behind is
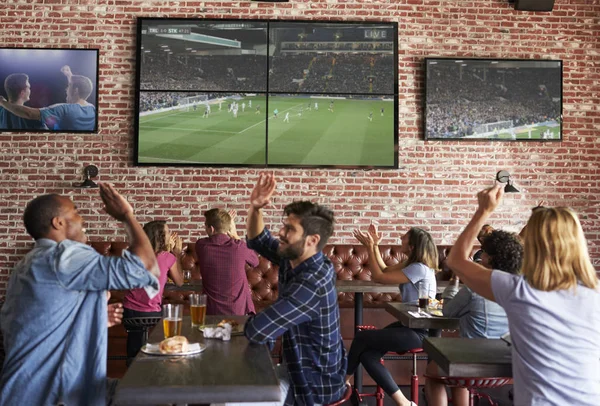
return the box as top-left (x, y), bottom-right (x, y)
top-left (447, 184), bottom-right (600, 406)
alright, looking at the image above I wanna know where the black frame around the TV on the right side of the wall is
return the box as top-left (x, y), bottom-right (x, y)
top-left (422, 56), bottom-right (564, 142)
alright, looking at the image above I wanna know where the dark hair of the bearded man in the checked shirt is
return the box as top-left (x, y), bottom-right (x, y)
top-left (283, 200), bottom-right (335, 251)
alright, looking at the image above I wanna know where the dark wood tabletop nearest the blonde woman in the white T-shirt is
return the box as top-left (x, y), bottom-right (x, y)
top-left (423, 337), bottom-right (512, 378)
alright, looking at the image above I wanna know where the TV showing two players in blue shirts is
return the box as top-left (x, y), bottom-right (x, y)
top-left (0, 48), bottom-right (98, 133)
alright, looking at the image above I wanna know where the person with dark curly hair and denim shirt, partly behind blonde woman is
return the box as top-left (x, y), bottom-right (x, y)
top-left (425, 230), bottom-right (523, 406)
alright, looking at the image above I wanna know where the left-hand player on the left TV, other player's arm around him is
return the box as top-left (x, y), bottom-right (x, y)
top-left (0, 73), bottom-right (47, 130)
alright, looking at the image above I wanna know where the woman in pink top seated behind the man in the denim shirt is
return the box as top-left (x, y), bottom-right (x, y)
top-left (123, 220), bottom-right (183, 364)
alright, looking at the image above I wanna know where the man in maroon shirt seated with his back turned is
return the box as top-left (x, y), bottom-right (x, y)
top-left (196, 209), bottom-right (258, 315)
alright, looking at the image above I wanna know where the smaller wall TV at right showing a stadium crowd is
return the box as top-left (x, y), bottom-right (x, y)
top-left (423, 58), bottom-right (562, 141)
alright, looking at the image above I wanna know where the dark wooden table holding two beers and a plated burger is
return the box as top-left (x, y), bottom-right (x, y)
top-left (115, 316), bottom-right (281, 405)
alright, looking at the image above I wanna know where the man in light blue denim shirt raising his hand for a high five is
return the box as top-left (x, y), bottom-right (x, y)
top-left (0, 184), bottom-right (158, 406)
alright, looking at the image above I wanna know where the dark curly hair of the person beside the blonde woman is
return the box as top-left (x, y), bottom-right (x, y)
top-left (481, 230), bottom-right (523, 274)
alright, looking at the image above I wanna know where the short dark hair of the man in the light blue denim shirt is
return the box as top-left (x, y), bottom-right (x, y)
top-left (23, 194), bottom-right (62, 240)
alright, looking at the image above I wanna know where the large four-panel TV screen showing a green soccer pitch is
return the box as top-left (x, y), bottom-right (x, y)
top-left (134, 18), bottom-right (398, 168)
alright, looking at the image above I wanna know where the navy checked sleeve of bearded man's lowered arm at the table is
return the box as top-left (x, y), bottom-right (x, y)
top-left (245, 281), bottom-right (319, 344)
